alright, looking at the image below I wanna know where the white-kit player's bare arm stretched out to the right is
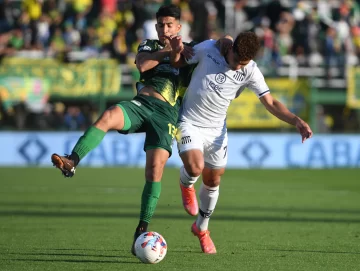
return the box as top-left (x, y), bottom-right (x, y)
top-left (260, 93), bottom-right (313, 142)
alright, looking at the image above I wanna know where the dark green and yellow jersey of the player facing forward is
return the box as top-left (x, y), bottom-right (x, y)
top-left (138, 39), bottom-right (195, 110)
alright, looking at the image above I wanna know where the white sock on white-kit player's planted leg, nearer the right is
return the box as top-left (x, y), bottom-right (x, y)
top-left (196, 183), bottom-right (219, 231)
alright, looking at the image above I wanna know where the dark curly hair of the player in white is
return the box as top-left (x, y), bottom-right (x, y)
top-left (233, 31), bottom-right (260, 61)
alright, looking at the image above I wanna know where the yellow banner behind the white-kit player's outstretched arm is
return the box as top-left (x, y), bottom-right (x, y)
top-left (227, 78), bottom-right (310, 129)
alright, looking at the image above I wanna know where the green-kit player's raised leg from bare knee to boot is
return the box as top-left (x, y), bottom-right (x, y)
top-left (51, 106), bottom-right (125, 177)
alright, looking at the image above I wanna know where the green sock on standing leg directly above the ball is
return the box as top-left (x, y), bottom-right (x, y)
top-left (140, 181), bottom-right (161, 223)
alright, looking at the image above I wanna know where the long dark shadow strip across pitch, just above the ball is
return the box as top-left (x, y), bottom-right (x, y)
top-left (0, 210), bottom-right (360, 223)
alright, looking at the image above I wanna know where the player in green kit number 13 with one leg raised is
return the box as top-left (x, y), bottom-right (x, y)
top-left (51, 5), bottom-right (192, 254)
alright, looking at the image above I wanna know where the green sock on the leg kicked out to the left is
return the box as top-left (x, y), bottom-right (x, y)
top-left (72, 126), bottom-right (106, 164)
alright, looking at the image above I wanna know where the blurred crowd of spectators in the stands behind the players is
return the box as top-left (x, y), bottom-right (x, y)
top-left (0, 0), bottom-right (360, 130)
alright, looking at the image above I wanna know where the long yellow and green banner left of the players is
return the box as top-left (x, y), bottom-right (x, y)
top-left (0, 58), bottom-right (121, 97)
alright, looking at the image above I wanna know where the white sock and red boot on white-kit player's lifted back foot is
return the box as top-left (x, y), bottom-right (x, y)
top-left (180, 166), bottom-right (199, 216)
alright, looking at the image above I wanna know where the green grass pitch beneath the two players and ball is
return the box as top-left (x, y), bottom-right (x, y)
top-left (0, 167), bottom-right (360, 271)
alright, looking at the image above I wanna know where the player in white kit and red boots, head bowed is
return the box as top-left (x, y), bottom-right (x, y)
top-left (169, 32), bottom-right (312, 254)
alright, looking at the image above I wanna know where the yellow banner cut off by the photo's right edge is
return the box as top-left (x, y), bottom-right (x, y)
top-left (346, 67), bottom-right (360, 109)
